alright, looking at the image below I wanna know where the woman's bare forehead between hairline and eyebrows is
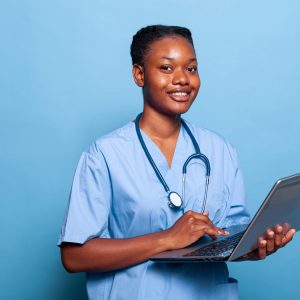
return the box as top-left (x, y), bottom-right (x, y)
top-left (145, 36), bottom-right (196, 62)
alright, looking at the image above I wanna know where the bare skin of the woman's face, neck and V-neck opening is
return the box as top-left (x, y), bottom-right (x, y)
top-left (133, 37), bottom-right (200, 166)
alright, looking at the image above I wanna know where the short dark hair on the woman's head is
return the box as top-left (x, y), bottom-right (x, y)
top-left (130, 25), bottom-right (194, 65)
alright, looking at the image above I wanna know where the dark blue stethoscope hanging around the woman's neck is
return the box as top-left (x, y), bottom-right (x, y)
top-left (135, 113), bottom-right (210, 213)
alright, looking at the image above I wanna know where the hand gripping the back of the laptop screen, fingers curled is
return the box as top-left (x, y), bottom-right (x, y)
top-left (237, 223), bottom-right (296, 261)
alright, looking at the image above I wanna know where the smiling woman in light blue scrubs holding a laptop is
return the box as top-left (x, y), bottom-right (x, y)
top-left (59, 25), bottom-right (294, 300)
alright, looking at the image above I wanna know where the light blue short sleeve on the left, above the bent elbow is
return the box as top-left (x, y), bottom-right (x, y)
top-left (58, 145), bottom-right (112, 246)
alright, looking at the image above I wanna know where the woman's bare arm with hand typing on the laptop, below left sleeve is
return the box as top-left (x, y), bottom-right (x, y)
top-left (61, 211), bottom-right (227, 272)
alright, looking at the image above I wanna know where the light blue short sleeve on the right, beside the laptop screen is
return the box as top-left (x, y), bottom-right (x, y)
top-left (224, 144), bottom-right (250, 227)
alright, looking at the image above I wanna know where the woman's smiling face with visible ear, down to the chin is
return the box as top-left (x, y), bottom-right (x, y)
top-left (133, 37), bottom-right (200, 115)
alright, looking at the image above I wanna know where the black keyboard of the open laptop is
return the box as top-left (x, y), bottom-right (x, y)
top-left (184, 231), bottom-right (245, 257)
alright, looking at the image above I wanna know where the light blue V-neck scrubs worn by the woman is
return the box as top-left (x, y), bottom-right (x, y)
top-left (59, 122), bottom-right (249, 300)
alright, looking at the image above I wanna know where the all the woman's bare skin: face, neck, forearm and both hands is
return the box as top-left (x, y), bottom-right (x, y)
top-left (61, 37), bottom-right (294, 272)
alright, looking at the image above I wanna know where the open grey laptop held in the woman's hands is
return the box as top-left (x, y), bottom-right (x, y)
top-left (150, 174), bottom-right (300, 263)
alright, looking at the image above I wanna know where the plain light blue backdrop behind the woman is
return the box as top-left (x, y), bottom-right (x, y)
top-left (0, 0), bottom-right (300, 300)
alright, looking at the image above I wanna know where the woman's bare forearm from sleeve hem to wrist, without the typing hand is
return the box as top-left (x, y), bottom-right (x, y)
top-left (61, 232), bottom-right (167, 272)
